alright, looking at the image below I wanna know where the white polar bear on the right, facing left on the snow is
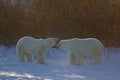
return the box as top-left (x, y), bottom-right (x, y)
top-left (57, 38), bottom-right (104, 65)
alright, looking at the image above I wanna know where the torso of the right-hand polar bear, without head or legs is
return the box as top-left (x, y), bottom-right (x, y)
top-left (70, 38), bottom-right (104, 55)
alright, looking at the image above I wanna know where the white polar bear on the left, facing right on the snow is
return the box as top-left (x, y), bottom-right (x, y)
top-left (16, 36), bottom-right (58, 64)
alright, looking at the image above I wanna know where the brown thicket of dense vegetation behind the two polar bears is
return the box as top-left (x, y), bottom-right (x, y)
top-left (0, 0), bottom-right (120, 47)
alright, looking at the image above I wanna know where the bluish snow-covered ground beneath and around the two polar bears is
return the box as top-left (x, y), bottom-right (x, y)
top-left (0, 46), bottom-right (120, 80)
